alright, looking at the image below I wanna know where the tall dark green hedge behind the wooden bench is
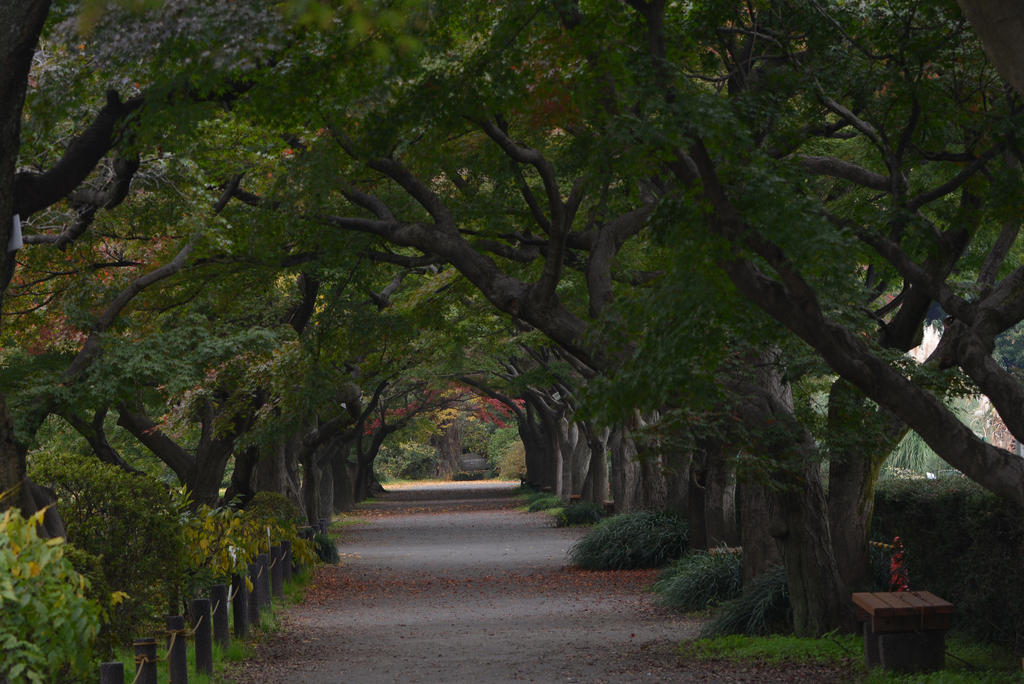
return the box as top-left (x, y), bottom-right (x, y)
top-left (872, 476), bottom-right (1024, 655)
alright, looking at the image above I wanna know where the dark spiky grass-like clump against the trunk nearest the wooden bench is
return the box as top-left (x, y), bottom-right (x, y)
top-left (700, 565), bottom-right (793, 639)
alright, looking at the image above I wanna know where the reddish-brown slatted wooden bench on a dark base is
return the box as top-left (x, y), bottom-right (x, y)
top-left (853, 592), bottom-right (953, 672)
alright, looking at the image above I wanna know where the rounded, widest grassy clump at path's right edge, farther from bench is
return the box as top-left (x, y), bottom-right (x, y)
top-left (569, 511), bottom-right (689, 570)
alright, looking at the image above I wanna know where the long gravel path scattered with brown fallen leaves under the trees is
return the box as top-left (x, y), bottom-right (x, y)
top-left (226, 483), bottom-right (696, 683)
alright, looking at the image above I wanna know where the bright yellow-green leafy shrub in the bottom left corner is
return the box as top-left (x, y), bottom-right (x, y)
top-left (0, 509), bottom-right (100, 684)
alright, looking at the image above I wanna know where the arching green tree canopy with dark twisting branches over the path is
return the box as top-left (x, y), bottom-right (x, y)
top-left (0, 0), bottom-right (1024, 632)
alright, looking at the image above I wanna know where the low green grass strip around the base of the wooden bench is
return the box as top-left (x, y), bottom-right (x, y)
top-left (679, 634), bottom-right (1024, 684)
